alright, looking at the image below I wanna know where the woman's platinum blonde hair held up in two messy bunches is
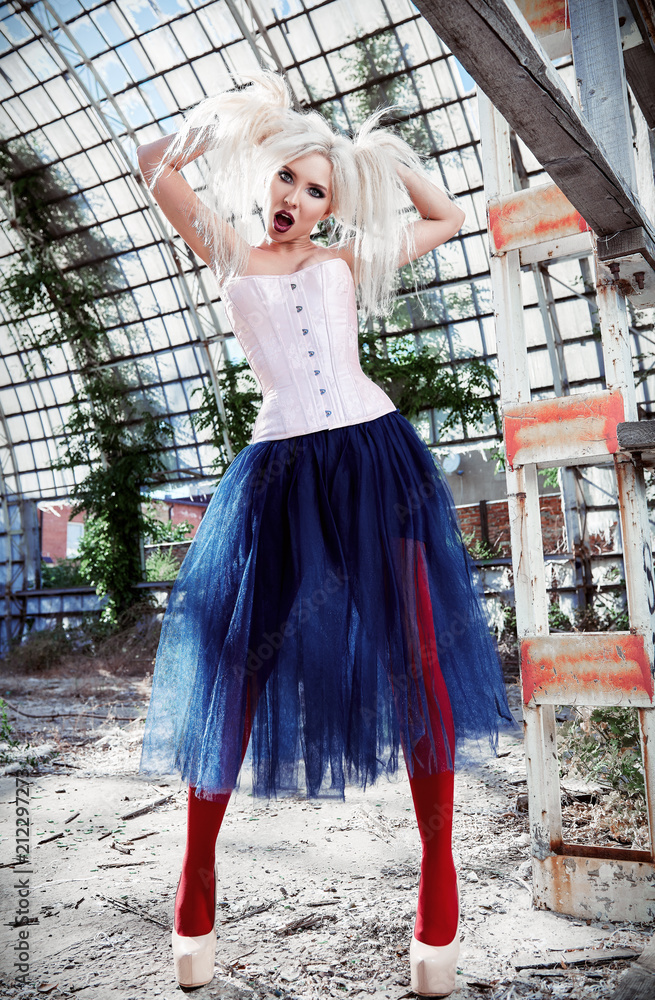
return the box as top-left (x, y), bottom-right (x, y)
top-left (151, 72), bottom-right (438, 315)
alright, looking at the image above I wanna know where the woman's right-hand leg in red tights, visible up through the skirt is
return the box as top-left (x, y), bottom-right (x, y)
top-left (405, 541), bottom-right (458, 945)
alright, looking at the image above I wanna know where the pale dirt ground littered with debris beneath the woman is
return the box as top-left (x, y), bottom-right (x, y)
top-left (0, 661), bottom-right (651, 1000)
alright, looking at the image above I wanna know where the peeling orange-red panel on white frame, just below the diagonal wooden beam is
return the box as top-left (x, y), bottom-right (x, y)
top-left (487, 182), bottom-right (589, 253)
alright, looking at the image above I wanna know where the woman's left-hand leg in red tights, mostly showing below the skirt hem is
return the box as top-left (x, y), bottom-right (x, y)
top-left (175, 690), bottom-right (252, 937)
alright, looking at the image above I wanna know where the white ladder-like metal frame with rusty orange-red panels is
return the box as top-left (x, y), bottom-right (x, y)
top-left (478, 93), bottom-right (655, 921)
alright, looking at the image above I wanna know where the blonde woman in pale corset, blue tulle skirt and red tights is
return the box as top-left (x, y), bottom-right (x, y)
top-left (138, 74), bottom-right (511, 996)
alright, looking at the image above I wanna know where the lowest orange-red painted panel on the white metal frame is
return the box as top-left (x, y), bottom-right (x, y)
top-left (521, 632), bottom-right (653, 707)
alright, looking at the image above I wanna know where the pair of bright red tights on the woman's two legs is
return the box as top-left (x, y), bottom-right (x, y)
top-left (175, 546), bottom-right (458, 945)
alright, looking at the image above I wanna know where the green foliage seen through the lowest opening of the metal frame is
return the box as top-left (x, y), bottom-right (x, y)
top-left (558, 708), bottom-right (645, 798)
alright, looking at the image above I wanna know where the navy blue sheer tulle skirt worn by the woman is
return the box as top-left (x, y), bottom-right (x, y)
top-left (140, 410), bottom-right (512, 799)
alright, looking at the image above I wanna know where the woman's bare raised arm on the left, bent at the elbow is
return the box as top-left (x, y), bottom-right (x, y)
top-left (136, 135), bottom-right (250, 264)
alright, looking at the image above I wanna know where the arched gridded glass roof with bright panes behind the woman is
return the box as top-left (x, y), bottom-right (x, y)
top-left (0, 0), bottom-right (653, 498)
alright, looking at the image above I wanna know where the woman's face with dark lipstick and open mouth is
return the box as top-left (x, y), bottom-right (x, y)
top-left (267, 153), bottom-right (332, 243)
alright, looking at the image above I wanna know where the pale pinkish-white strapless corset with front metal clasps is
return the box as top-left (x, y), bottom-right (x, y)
top-left (222, 257), bottom-right (396, 443)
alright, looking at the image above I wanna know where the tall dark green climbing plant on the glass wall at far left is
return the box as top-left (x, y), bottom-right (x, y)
top-left (0, 144), bottom-right (171, 622)
